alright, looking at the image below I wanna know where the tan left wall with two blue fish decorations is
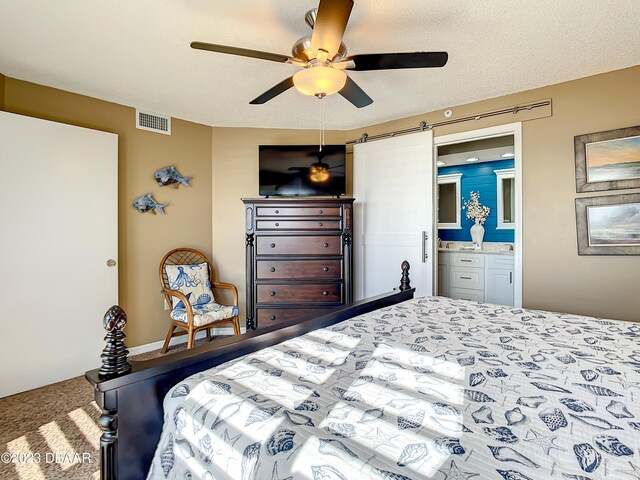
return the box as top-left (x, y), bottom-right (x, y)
top-left (0, 78), bottom-right (214, 346)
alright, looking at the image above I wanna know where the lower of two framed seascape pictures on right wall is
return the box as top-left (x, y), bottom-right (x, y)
top-left (576, 193), bottom-right (640, 255)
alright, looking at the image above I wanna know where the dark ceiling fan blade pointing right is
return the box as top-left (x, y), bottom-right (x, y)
top-left (340, 52), bottom-right (449, 71)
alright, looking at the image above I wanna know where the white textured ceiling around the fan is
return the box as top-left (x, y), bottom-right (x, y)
top-left (0, 0), bottom-right (640, 129)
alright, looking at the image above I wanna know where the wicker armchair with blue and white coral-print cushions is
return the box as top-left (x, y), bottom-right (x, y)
top-left (159, 248), bottom-right (240, 353)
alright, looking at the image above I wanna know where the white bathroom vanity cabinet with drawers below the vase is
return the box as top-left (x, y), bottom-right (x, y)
top-left (438, 252), bottom-right (513, 305)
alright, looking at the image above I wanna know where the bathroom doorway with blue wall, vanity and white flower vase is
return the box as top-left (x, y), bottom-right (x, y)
top-left (433, 123), bottom-right (522, 306)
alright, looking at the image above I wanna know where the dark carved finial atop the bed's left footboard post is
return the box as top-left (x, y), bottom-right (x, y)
top-left (98, 305), bottom-right (131, 378)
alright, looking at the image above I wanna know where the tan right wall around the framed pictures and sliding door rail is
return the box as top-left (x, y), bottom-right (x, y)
top-left (348, 62), bottom-right (640, 321)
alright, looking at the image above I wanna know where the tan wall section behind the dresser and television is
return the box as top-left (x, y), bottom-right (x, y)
top-left (212, 128), bottom-right (347, 324)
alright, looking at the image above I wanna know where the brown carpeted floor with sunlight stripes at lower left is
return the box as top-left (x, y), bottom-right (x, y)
top-left (0, 339), bottom-right (220, 480)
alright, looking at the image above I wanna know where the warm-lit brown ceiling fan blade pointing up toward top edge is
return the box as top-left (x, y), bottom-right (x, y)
top-left (311, 0), bottom-right (353, 60)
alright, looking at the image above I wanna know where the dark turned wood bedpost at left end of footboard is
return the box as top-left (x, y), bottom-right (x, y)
top-left (95, 305), bottom-right (131, 479)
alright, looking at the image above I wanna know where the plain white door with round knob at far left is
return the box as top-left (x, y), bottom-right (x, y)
top-left (0, 112), bottom-right (118, 397)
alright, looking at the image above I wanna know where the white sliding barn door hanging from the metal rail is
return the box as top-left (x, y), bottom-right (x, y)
top-left (353, 131), bottom-right (434, 300)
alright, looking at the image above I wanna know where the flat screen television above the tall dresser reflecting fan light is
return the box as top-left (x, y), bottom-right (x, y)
top-left (258, 145), bottom-right (347, 197)
